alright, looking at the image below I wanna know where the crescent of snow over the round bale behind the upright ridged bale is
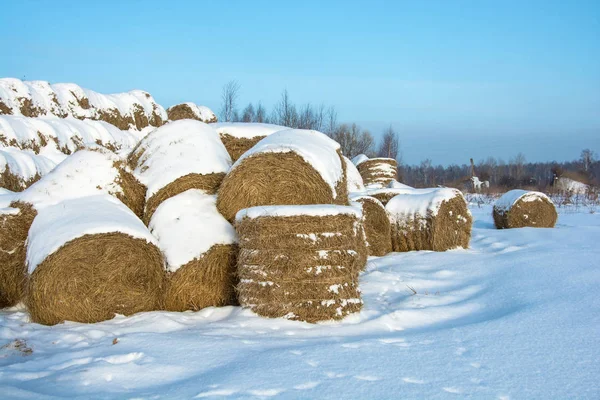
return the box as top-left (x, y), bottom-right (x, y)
top-left (232, 129), bottom-right (343, 198)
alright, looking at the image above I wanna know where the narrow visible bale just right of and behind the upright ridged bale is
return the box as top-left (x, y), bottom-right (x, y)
top-left (350, 195), bottom-right (392, 256)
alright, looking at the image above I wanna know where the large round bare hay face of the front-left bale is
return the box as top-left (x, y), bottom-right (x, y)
top-left (26, 233), bottom-right (165, 325)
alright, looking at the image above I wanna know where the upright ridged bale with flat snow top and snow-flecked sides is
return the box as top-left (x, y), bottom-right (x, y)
top-left (235, 205), bottom-right (366, 322)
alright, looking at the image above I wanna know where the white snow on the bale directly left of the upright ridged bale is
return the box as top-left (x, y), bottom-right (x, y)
top-left (148, 189), bottom-right (237, 272)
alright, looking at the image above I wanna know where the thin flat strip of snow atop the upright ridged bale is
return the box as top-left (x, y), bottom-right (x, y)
top-left (235, 204), bottom-right (362, 221)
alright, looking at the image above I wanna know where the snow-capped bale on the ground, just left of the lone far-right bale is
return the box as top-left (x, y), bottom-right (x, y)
top-left (386, 188), bottom-right (473, 251)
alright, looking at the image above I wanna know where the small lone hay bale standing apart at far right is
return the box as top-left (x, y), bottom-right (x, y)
top-left (493, 189), bottom-right (558, 229)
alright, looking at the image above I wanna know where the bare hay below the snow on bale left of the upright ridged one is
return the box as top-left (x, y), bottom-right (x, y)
top-left (164, 245), bottom-right (237, 311)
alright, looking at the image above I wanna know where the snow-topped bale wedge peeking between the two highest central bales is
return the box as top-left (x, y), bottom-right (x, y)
top-left (215, 122), bottom-right (289, 162)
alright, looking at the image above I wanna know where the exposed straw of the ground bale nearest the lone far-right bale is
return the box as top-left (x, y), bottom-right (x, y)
top-left (386, 189), bottom-right (473, 252)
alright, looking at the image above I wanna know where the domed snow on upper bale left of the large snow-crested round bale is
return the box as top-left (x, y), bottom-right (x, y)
top-left (135, 119), bottom-right (231, 199)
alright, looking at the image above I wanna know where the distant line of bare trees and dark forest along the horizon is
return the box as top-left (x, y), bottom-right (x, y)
top-left (219, 81), bottom-right (600, 191)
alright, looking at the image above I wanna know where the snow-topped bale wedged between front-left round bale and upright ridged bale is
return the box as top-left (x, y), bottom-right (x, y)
top-left (148, 189), bottom-right (237, 311)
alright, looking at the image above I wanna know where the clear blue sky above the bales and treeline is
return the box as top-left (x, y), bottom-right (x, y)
top-left (0, 0), bottom-right (600, 164)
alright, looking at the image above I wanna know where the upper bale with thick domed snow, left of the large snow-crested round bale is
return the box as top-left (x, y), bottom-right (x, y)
top-left (130, 119), bottom-right (231, 224)
